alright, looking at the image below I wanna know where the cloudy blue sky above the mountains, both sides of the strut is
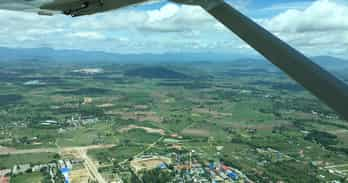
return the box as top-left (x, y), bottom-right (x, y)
top-left (0, 0), bottom-right (348, 58)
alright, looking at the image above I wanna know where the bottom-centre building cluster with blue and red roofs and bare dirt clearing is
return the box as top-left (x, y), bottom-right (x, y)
top-left (123, 148), bottom-right (252, 183)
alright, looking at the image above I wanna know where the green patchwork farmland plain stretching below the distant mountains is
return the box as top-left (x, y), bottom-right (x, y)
top-left (0, 60), bottom-right (348, 182)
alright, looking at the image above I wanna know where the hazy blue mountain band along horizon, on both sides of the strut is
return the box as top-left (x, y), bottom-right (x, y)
top-left (0, 47), bottom-right (348, 71)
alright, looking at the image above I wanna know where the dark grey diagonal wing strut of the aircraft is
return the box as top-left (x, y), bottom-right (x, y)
top-left (192, 0), bottom-right (348, 121)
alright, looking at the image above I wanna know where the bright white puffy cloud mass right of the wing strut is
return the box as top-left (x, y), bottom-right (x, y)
top-left (259, 0), bottom-right (348, 56)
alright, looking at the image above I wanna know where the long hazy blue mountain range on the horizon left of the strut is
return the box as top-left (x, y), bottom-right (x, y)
top-left (0, 47), bottom-right (246, 62)
